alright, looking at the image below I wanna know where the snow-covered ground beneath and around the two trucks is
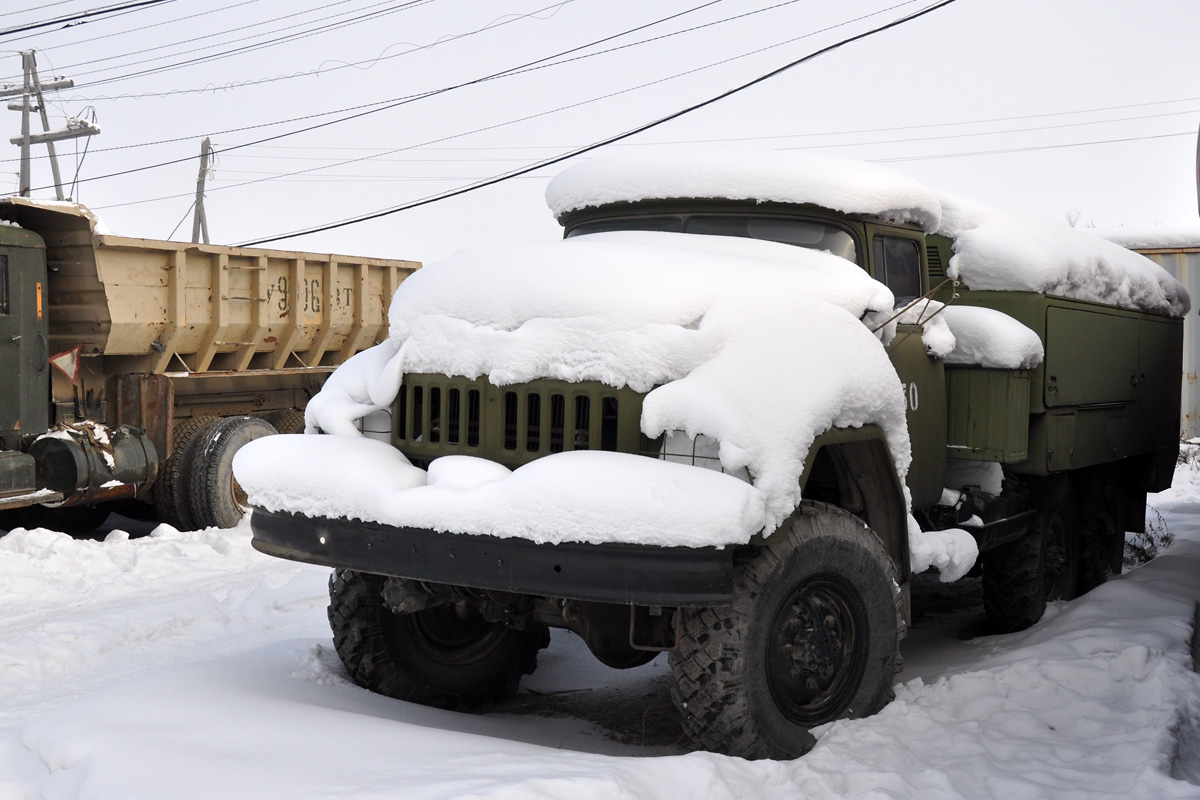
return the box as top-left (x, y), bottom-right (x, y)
top-left (0, 467), bottom-right (1200, 800)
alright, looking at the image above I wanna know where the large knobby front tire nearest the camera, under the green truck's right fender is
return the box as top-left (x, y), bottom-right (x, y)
top-left (670, 503), bottom-right (904, 758)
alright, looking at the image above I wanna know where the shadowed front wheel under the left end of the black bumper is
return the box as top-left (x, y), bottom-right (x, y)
top-left (329, 570), bottom-right (550, 711)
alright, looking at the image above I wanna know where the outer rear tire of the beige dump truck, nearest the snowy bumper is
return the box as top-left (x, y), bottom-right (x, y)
top-left (187, 416), bottom-right (278, 528)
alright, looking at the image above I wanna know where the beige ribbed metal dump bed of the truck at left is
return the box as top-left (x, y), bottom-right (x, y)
top-left (0, 198), bottom-right (420, 374)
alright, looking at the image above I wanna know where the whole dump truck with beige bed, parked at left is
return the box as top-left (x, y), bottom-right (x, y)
top-left (0, 198), bottom-right (419, 534)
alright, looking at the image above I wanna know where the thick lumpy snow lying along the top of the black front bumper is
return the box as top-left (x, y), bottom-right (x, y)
top-left (234, 435), bottom-right (766, 547)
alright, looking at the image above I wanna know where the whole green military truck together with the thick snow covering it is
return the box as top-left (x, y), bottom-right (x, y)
top-left (235, 152), bottom-right (1189, 758)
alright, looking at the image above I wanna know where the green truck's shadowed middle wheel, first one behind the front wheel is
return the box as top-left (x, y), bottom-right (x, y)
top-left (982, 504), bottom-right (1080, 633)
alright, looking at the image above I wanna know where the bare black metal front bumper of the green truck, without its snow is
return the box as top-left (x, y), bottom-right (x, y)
top-left (251, 509), bottom-right (733, 606)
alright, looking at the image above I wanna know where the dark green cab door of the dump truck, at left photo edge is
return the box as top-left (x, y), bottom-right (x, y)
top-left (0, 235), bottom-right (50, 437)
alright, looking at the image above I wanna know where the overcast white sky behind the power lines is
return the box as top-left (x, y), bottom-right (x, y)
top-left (0, 0), bottom-right (1200, 261)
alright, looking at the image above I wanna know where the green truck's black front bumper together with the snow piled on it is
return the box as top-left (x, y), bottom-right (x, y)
top-left (234, 435), bottom-right (763, 606)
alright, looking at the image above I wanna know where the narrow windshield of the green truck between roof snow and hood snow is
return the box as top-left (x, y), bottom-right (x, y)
top-left (566, 213), bottom-right (858, 263)
